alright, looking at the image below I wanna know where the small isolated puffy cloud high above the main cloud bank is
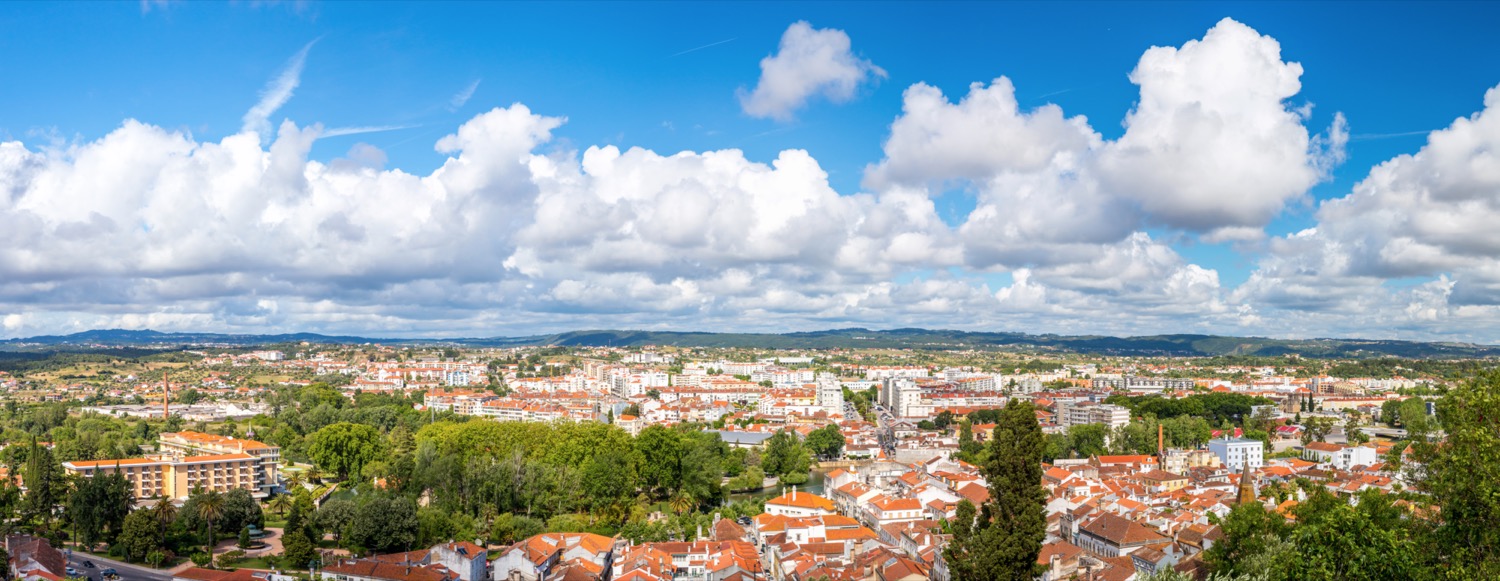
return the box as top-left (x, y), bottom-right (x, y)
top-left (740, 21), bottom-right (885, 120)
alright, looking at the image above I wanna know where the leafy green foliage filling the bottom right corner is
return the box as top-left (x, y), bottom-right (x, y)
top-left (1205, 372), bottom-right (1500, 579)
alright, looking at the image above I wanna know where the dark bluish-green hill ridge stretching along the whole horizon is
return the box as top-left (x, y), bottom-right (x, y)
top-left (0, 329), bottom-right (1500, 359)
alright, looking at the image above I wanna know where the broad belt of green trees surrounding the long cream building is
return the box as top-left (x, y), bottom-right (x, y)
top-left (0, 384), bottom-right (845, 567)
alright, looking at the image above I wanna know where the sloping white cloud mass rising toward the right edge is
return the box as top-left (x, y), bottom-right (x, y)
top-left (1235, 87), bottom-right (1500, 341)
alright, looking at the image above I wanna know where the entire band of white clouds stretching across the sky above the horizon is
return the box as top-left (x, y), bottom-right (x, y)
top-left (0, 21), bottom-right (1500, 341)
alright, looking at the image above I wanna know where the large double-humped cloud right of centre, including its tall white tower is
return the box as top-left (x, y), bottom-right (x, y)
top-left (864, 20), bottom-right (1349, 269)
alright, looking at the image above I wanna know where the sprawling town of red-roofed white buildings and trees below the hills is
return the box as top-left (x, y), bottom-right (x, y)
top-left (0, 342), bottom-right (1482, 581)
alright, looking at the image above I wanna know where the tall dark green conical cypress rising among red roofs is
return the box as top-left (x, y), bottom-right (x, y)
top-left (944, 399), bottom-right (1047, 581)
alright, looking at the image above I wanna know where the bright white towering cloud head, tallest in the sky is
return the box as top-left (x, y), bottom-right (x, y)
top-left (1100, 18), bottom-right (1326, 231)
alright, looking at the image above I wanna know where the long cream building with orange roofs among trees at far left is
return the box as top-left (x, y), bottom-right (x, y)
top-left (63, 453), bottom-right (261, 500)
